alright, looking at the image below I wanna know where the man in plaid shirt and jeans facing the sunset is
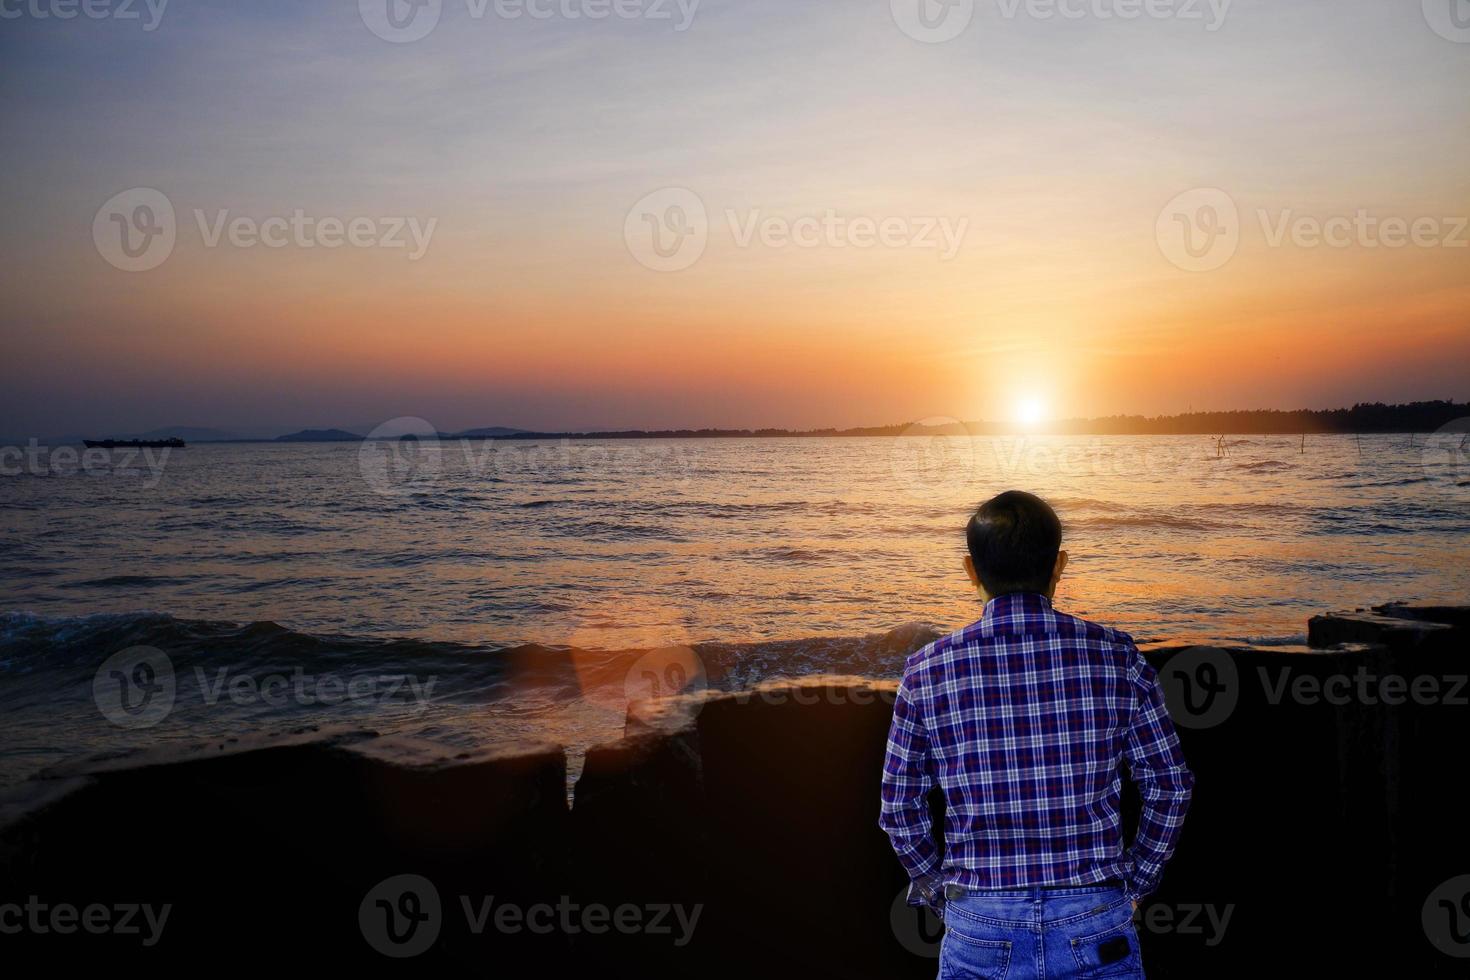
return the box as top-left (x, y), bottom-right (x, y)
top-left (879, 491), bottom-right (1194, 980)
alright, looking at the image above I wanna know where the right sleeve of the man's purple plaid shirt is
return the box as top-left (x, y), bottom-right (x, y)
top-left (1123, 646), bottom-right (1194, 901)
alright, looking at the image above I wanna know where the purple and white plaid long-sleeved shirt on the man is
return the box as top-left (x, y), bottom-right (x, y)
top-left (879, 592), bottom-right (1194, 911)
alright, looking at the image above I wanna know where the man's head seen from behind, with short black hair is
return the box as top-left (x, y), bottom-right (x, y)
top-left (964, 491), bottom-right (1061, 598)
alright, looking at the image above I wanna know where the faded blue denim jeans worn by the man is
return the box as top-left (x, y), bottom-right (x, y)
top-left (939, 884), bottom-right (1144, 980)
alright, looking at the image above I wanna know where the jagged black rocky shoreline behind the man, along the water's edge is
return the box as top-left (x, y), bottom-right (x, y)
top-left (0, 605), bottom-right (1470, 979)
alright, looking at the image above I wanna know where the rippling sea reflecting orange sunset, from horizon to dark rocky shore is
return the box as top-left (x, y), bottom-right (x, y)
top-left (0, 432), bottom-right (1470, 786)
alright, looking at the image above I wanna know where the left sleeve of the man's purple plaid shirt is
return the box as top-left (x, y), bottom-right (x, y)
top-left (878, 679), bottom-right (941, 905)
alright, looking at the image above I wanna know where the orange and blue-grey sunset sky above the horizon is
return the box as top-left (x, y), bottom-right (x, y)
top-left (0, 0), bottom-right (1470, 438)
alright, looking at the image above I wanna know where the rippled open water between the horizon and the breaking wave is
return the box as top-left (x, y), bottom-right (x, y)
top-left (0, 436), bottom-right (1470, 649)
